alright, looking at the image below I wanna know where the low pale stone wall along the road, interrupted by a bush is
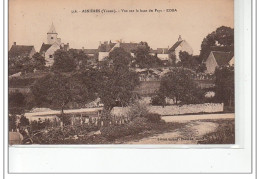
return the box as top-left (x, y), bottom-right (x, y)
top-left (112, 103), bottom-right (224, 116)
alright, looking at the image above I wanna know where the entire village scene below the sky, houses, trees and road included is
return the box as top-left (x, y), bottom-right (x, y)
top-left (8, 23), bottom-right (235, 145)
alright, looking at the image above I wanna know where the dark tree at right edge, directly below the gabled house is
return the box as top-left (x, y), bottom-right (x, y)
top-left (215, 67), bottom-right (235, 106)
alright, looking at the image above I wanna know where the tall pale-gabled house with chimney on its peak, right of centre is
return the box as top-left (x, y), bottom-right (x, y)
top-left (169, 36), bottom-right (193, 63)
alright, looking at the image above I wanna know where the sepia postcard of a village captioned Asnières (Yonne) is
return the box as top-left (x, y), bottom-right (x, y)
top-left (8, 0), bottom-right (235, 145)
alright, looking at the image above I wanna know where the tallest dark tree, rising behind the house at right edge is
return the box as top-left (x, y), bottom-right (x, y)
top-left (199, 26), bottom-right (234, 62)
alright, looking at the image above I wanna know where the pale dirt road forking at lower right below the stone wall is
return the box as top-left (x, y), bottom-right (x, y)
top-left (127, 114), bottom-right (234, 144)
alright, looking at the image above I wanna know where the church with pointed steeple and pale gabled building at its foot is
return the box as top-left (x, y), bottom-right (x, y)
top-left (40, 23), bottom-right (69, 66)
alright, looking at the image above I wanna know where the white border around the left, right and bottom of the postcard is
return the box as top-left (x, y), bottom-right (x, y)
top-left (4, 0), bottom-right (255, 173)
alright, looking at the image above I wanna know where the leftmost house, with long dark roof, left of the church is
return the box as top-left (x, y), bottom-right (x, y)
top-left (8, 42), bottom-right (36, 58)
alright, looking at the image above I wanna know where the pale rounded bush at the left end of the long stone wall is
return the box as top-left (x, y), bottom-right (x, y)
top-left (127, 101), bottom-right (149, 120)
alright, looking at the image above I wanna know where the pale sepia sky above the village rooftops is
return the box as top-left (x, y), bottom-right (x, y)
top-left (9, 0), bottom-right (234, 55)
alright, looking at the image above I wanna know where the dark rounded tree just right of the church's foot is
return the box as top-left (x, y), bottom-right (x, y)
top-left (52, 50), bottom-right (76, 72)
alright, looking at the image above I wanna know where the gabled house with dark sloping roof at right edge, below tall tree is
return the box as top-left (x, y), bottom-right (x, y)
top-left (204, 51), bottom-right (234, 74)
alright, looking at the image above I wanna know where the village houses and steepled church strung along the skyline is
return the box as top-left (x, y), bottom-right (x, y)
top-left (9, 23), bottom-right (234, 74)
